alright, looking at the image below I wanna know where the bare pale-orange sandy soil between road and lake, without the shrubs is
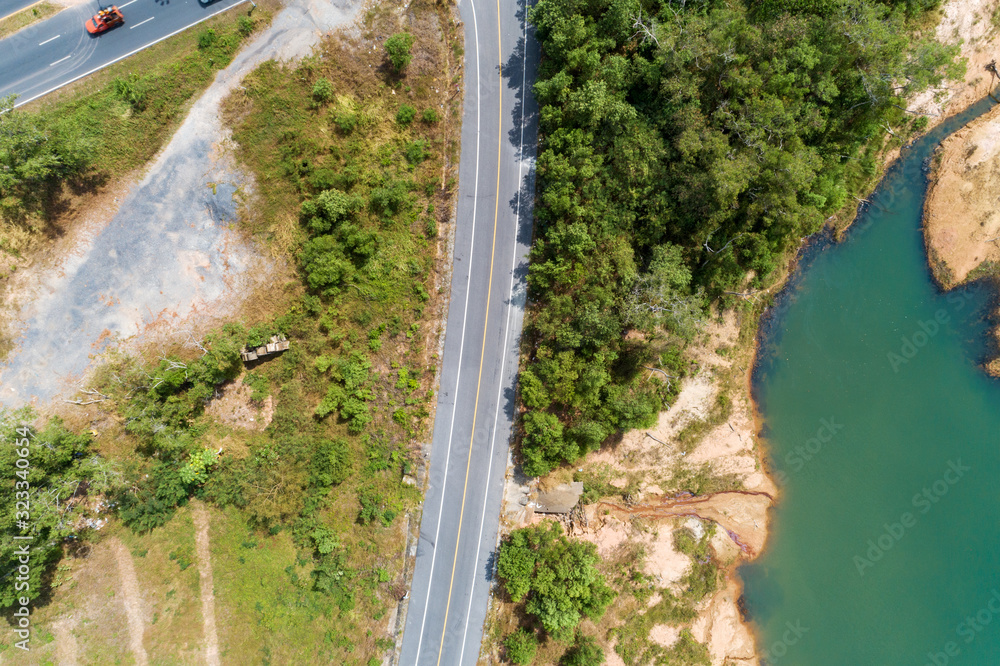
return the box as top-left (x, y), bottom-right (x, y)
top-left (544, 313), bottom-right (760, 665)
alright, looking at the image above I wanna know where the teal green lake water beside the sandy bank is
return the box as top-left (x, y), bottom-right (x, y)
top-left (740, 97), bottom-right (1000, 666)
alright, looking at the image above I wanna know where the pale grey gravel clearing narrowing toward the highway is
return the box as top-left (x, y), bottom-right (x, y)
top-left (0, 0), bottom-right (360, 405)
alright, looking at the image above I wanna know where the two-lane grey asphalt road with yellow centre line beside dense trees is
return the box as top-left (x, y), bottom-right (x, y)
top-left (400, 0), bottom-right (538, 666)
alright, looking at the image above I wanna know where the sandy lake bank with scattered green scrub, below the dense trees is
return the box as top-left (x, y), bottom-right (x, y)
top-left (480, 308), bottom-right (777, 666)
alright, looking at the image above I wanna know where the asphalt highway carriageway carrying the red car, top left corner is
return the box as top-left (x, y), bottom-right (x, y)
top-left (0, 0), bottom-right (246, 106)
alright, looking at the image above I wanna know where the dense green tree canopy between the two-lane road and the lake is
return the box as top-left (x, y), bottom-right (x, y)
top-left (521, 0), bottom-right (962, 474)
